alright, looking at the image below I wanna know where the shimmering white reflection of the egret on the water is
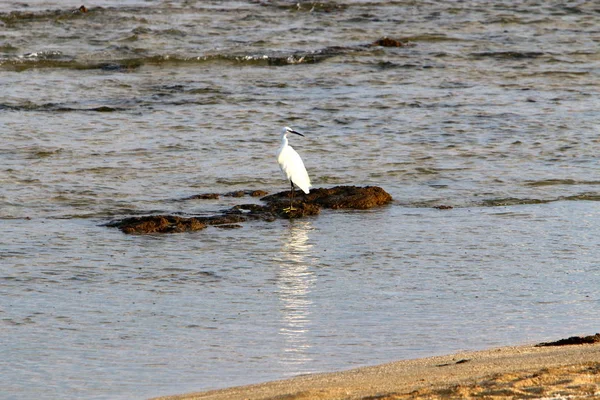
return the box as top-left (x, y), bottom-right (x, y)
top-left (277, 221), bottom-right (316, 375)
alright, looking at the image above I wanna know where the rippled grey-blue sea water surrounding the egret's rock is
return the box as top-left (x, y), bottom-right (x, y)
top-left (0, 0), bottom-right (600, 399)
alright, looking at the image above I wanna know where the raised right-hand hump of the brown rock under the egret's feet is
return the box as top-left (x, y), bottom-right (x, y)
top-left (261, 186), bottom-right (392, 210)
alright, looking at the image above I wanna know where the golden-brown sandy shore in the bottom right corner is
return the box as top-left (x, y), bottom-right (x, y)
top-left (159, 343), bottom-right (600, 400)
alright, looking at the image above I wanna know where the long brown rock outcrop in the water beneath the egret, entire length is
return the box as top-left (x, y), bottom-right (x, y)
top-left (106, 186), bottom-right (392, 234)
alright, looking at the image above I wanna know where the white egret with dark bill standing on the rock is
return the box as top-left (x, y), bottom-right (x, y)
top-left (277, 126), bottom-right (312, 211)
